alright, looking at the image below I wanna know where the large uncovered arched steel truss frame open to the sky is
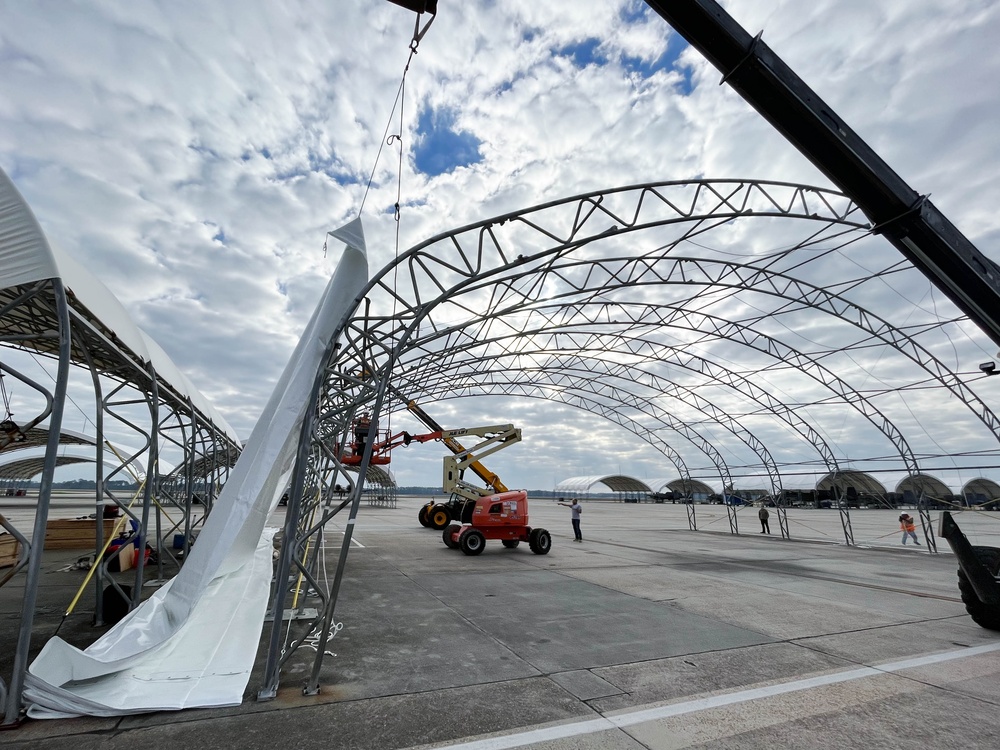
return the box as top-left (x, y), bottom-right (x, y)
top-left (259, 180), bottom-right (1000, 699)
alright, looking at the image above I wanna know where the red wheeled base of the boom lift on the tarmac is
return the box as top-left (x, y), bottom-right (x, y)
top-left (442, 490), bottom-right (552, 555)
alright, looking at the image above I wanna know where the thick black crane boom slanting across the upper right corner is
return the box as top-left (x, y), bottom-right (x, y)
top-left (646, 0), bottom-right (1000, 346)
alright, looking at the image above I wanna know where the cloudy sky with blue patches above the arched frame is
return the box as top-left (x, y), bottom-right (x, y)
top-left (0, 0), bottom-right (1000, 488)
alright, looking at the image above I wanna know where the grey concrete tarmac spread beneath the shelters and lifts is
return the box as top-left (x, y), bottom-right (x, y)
top-left (0, 498), bottom-right (1000, 750)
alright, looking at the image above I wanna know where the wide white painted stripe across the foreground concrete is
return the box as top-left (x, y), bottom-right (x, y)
top-left (412, 643), bottom-right (1000, 750)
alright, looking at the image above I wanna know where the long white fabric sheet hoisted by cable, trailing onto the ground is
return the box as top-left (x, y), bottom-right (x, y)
top-left (24, 219), bottom-right (368, 718)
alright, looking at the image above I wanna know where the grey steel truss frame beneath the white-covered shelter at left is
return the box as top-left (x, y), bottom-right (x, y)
top-left (0, 278), bottom-right (241, 725)
